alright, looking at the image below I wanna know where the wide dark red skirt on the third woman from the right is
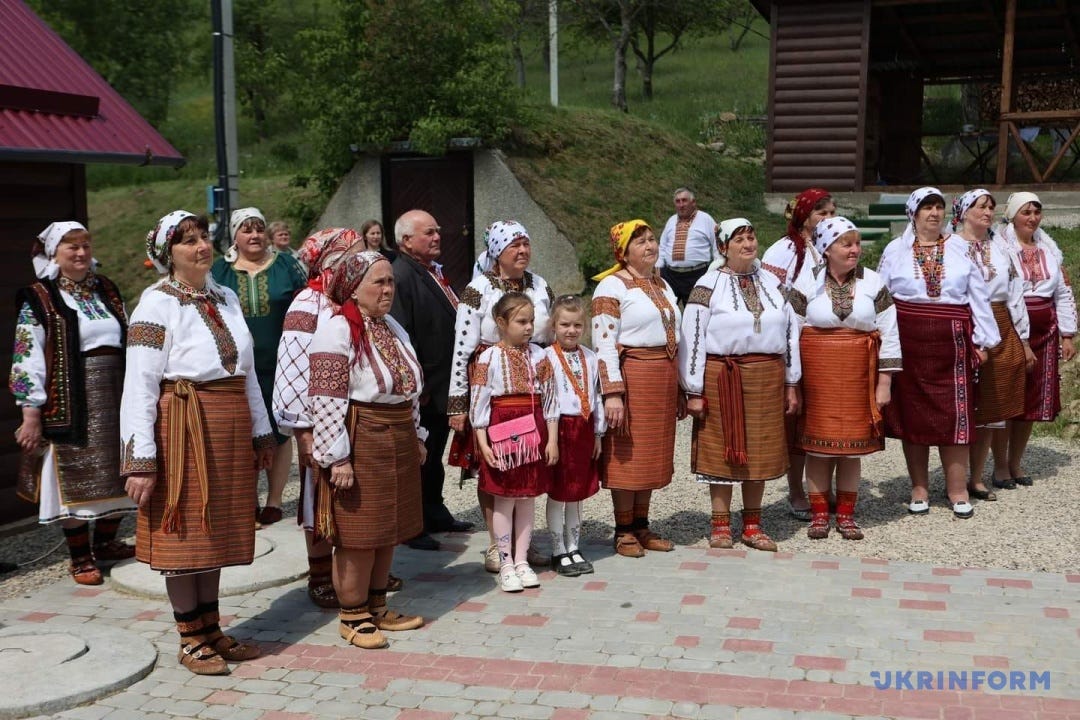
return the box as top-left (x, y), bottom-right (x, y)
top-left (882, 300), bottom-right (977, 446)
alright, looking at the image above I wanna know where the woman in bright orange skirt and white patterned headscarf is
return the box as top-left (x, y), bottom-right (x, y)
top-left (789, 217), bottom-right (901, 540)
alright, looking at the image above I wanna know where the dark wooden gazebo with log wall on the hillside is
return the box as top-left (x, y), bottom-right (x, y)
top-left (753, 0), bottom-right (1080, 192)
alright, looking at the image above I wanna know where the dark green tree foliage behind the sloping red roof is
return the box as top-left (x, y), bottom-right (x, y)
top-left (29, 0), bottom-right (196, 125)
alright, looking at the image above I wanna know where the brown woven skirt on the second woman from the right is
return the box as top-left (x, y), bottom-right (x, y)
top-left (975, 302), bottom-right (1027, 425)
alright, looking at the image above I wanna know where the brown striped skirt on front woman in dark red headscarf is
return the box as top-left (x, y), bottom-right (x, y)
top-left (316, 402), bottom-right (423, 549)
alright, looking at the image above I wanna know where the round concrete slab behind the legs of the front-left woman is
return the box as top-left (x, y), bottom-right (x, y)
top-left (110, 520), bottom-right (308, 600)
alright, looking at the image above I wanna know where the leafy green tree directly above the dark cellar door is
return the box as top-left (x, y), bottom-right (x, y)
top-left (298, 0), bottom-right (519, 189)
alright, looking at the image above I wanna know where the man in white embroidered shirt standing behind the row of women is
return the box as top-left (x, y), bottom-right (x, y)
top-left (657, 188), bottom-right (716, 305)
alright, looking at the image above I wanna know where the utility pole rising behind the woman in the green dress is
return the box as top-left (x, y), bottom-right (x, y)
top-left (211, 0), bottom-right (240, 250)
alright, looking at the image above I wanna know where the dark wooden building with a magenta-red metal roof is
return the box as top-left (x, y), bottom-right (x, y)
top-left (0, 0), bottom-right (184, 522)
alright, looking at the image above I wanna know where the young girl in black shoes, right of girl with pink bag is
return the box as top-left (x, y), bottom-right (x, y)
top-left (546, 295), bottom-right (607, 578)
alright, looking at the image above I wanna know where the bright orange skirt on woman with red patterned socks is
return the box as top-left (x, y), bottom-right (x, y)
top-left (798, 327), bottom-right (885, 457)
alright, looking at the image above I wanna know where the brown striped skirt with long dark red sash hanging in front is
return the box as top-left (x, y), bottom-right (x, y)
top-left (690, 354), bottom-right (787, 483)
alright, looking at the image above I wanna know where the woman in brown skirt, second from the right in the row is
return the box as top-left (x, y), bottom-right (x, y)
top-left (953, 188), bottom-right (1035, 500)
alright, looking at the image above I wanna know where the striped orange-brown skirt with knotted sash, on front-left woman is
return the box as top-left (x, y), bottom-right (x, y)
top-left (135, 377), bottom-right (255, 574)
